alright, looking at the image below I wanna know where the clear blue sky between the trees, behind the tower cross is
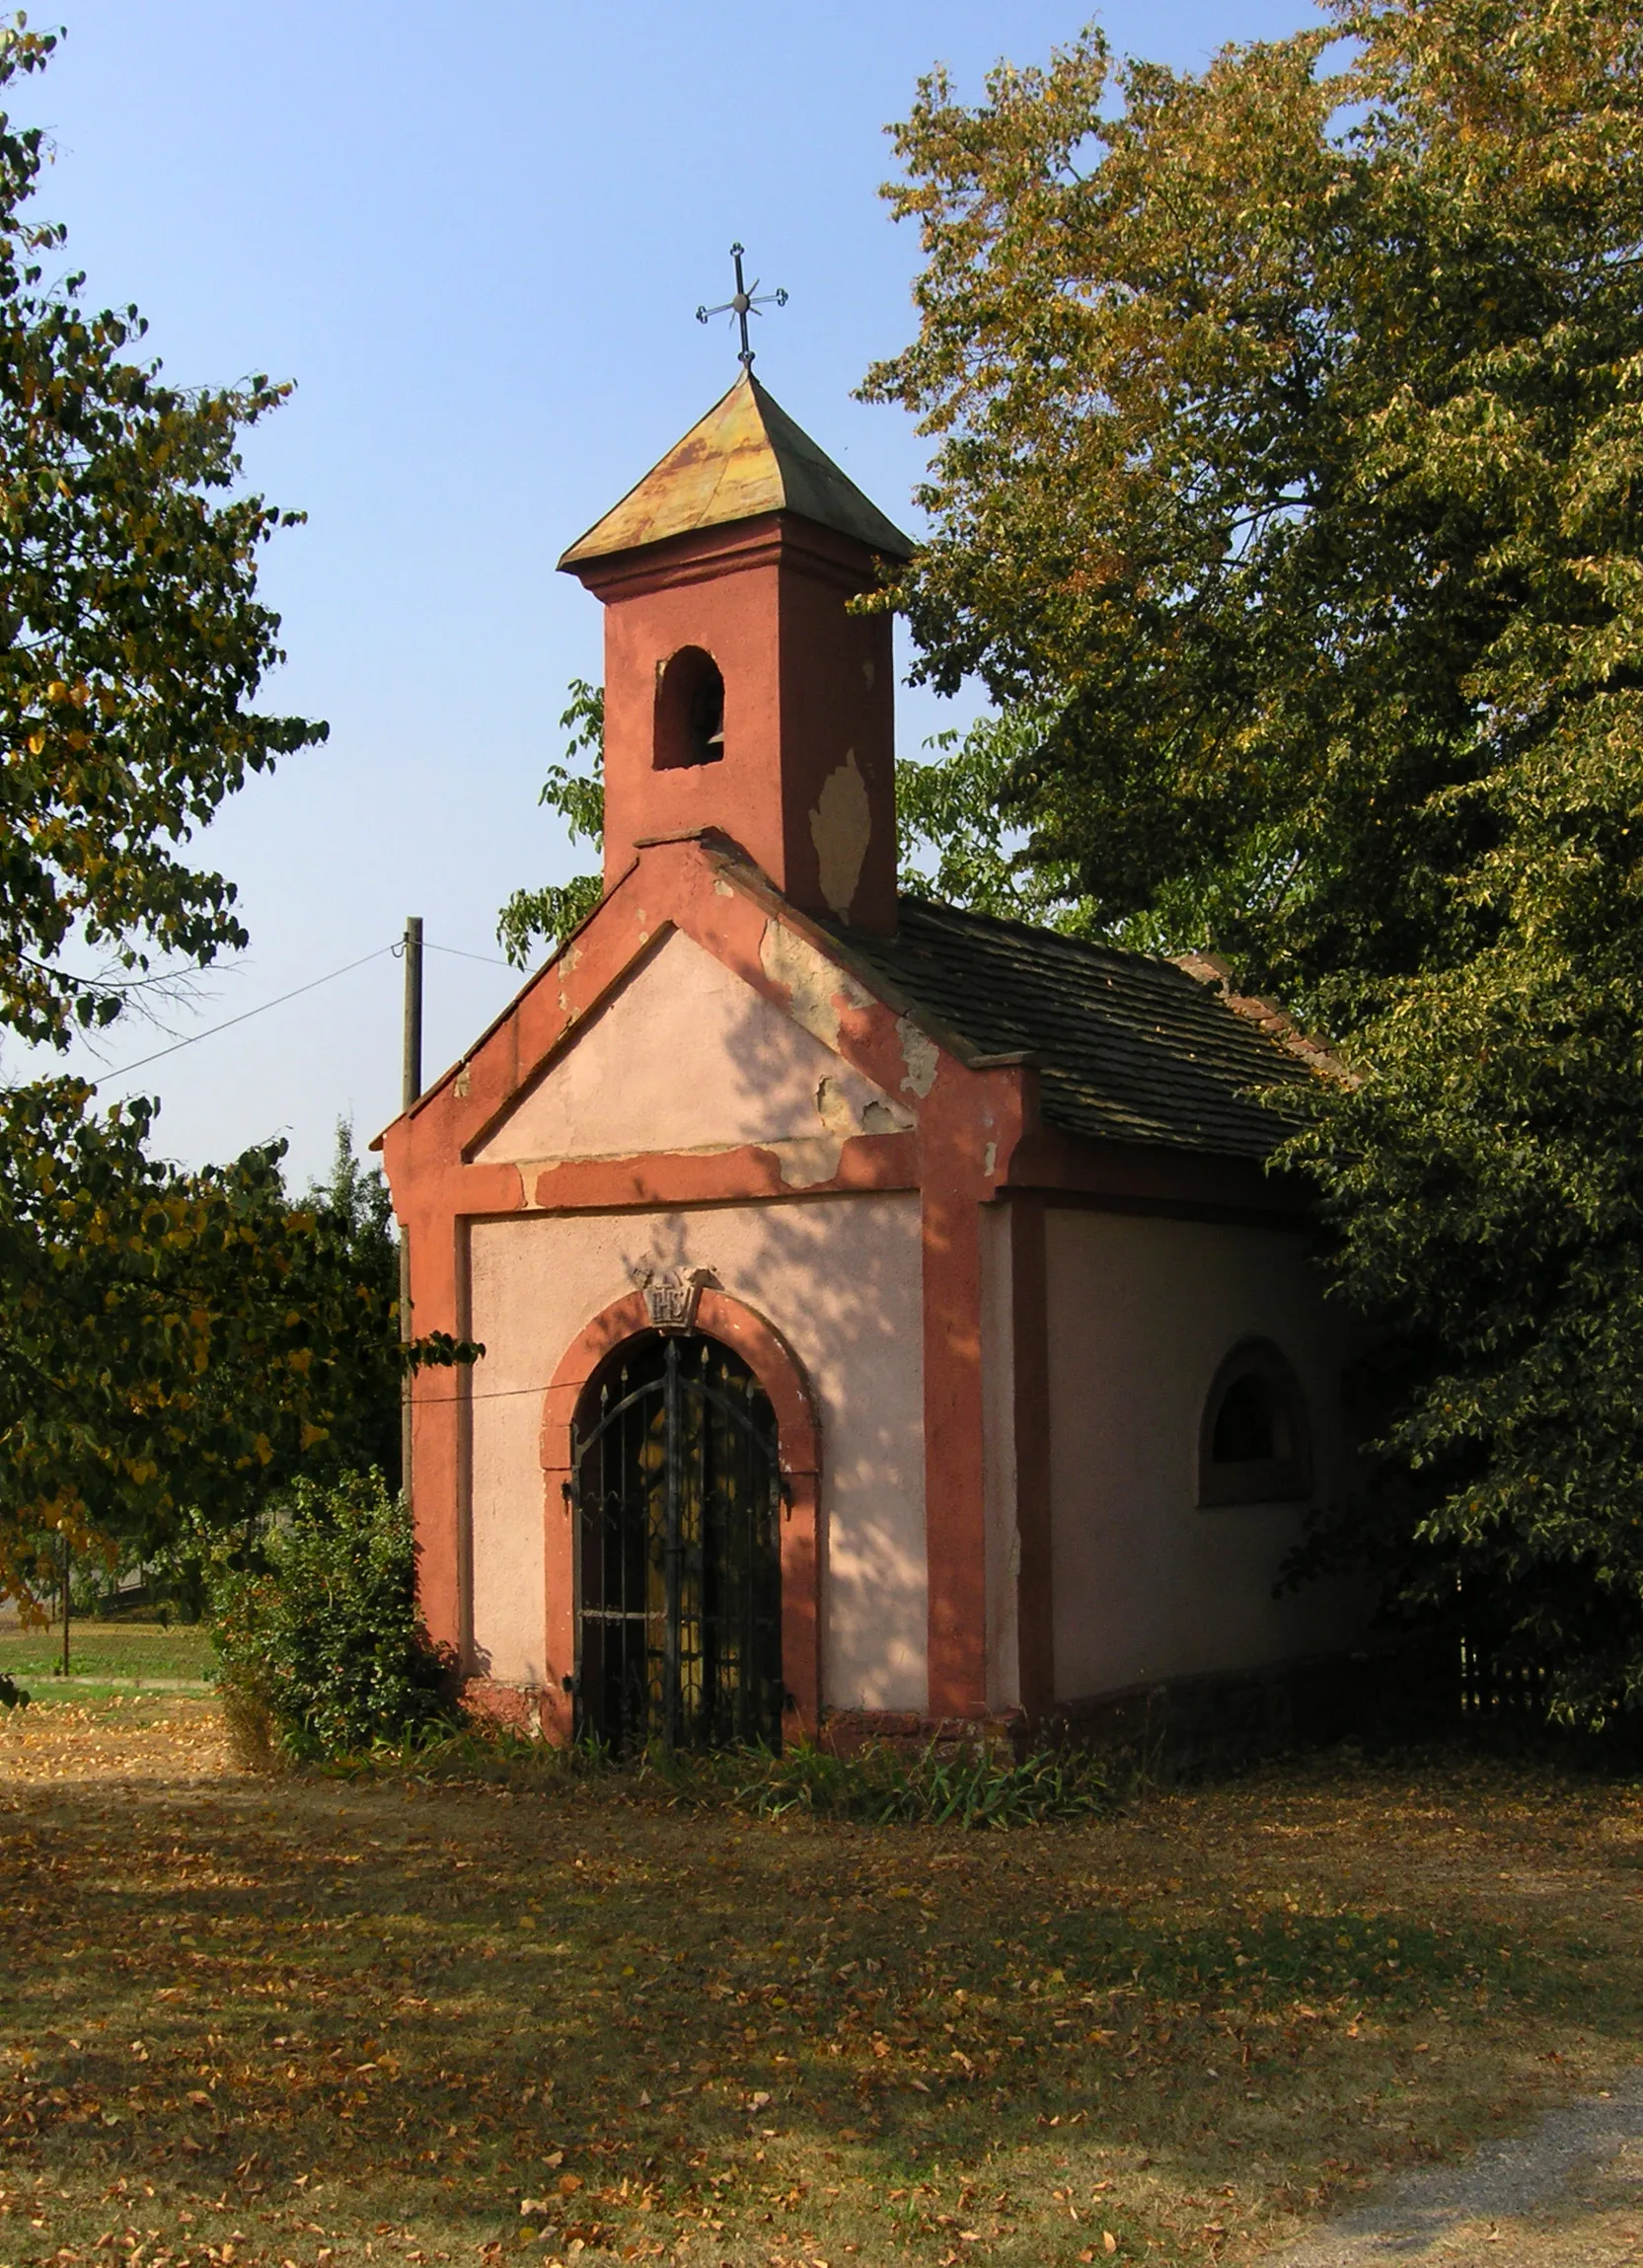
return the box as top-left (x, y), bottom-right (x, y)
top-left (0, 0), bottom-right (1314, 1179)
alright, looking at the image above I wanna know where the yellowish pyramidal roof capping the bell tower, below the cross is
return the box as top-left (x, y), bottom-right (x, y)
top-left (560, 370), bottom-right (914, 569)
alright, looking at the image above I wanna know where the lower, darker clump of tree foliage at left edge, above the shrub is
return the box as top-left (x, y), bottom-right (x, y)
top-left (0, 1080), bottom-right (397, 1590)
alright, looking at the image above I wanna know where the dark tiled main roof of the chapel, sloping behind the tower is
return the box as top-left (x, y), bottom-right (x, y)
top-left (848, 898), bottom-right (1314, 1157)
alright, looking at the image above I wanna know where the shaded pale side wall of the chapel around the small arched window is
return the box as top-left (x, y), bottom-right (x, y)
top-left (1045, 1209), bottom-right (1360, 1701)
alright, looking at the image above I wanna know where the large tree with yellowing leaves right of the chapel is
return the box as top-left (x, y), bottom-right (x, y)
top-left (868, 0), bottom-right (1643, 1719)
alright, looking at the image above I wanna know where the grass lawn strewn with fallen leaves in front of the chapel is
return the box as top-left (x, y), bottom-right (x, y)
top-left (0, 1697), bottom-right (1643, 2268)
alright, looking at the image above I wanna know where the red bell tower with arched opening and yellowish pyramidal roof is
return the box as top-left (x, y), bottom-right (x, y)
top-left (560, 370), bottom-right (911, 935)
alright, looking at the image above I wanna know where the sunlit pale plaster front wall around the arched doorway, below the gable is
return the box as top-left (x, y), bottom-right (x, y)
top-left (469, 1195), bottom-right (927, 1710)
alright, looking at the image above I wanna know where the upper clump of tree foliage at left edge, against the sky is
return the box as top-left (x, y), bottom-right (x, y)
top-left (0, 18), bottom-right (327, 1043)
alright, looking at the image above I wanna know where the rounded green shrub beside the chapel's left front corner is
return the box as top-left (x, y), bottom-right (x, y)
top-left (211, 1472), bottom-right (456, 1769)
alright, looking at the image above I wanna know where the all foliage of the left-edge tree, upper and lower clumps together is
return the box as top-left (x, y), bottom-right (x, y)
top-left (0, 18), bottom-right (462, 1597)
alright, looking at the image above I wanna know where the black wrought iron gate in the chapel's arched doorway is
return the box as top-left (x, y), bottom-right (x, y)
top-left (571, 1331), bottom-right (782, 1751)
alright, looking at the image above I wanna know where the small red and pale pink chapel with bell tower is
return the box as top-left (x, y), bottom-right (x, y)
top-left (383, 367), bottom-right (1360, 1749)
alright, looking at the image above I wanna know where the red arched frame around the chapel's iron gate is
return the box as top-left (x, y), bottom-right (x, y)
top-left (542, 1286), bottom-right (820, 1742)
